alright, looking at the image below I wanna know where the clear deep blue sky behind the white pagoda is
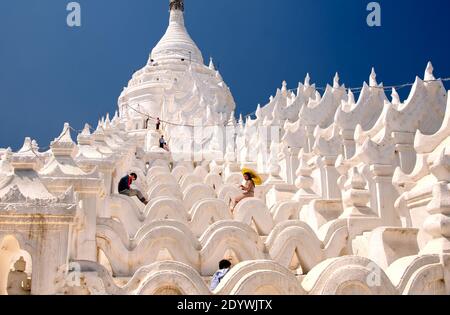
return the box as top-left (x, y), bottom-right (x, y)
top-left (0, 0), bottom-right (450, 149)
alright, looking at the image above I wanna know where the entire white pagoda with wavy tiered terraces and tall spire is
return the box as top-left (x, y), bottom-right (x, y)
top-left (0, 0), bottom-right (450, 296)
